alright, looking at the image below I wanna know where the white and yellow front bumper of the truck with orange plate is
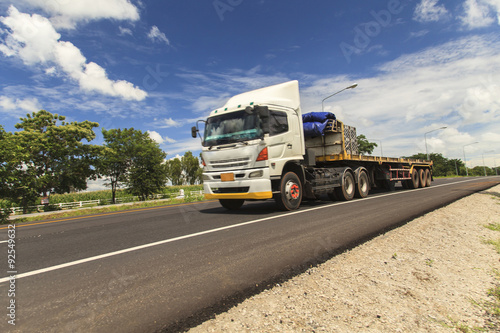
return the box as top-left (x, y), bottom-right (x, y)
top-left (203, 168), bottom-right (273, 200)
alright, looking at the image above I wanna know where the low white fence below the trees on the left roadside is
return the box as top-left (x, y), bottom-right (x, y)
top-left (10, 190), bottom-right (203, 215)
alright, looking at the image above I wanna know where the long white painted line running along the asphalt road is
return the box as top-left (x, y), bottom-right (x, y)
top-left (0, 179), bottom-right (492, 283)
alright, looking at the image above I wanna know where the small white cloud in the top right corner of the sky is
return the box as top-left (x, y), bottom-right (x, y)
top-left (460, 0), bottom-right (500, 29)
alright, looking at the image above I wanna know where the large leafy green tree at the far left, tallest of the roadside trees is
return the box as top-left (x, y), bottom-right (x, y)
top-left (0, 110), bottom-right (99, 212)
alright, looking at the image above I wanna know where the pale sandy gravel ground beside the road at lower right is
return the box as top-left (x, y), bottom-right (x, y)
top-left (190, 185), bottom-right (500, 333)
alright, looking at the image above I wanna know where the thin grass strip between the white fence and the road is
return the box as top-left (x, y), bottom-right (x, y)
top-left (7, 195), bottom-right (204, 224)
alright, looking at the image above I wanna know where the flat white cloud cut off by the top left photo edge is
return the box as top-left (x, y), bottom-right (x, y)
top-left (2, 0), bottom-right (139, 29)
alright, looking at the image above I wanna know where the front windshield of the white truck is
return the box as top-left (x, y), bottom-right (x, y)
top-left (203, 110), bottom-right (264, 147)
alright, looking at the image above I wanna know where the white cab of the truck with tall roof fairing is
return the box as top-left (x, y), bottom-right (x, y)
top-left (193, 81), bottom-right (305, 209)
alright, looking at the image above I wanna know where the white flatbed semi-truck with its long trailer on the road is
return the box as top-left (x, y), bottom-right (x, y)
top-left (192, 81), bottom-right (432, 210)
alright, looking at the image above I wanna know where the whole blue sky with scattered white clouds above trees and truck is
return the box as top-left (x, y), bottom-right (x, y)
top-left (0, 0), bottom-right (500, 171)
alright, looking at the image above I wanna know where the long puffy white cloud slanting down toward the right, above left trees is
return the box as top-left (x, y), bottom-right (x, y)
top-left (0, 6), bottom-right (147, 101)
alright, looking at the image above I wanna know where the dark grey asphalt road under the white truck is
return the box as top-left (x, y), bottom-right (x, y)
top-left (0, 177), bottom-right (500, 332)
